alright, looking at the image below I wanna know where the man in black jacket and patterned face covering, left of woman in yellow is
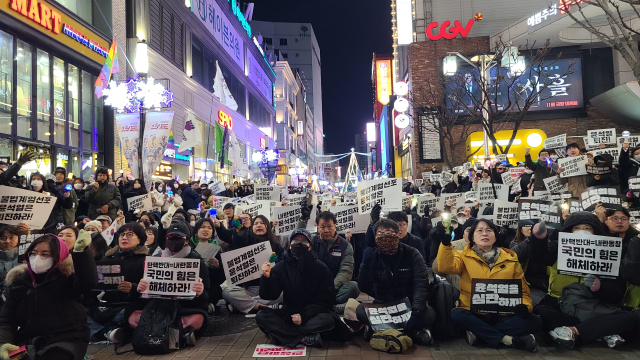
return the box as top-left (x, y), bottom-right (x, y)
top-left (356, 219), bottom-right (435, 345)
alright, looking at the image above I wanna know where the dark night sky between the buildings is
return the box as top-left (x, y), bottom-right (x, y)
top-left (253, 0), bottom-right (393, 165)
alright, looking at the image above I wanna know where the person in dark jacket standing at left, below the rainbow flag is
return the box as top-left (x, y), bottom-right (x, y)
top-left (85, 167), bottom-right (122, 220)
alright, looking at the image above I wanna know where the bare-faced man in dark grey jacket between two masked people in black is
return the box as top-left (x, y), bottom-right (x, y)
top-left (298, 208), bottom-right (360, 306)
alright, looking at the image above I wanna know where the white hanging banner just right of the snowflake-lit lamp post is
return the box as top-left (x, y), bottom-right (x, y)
top-left (141, 111), bottom-right (173, 189)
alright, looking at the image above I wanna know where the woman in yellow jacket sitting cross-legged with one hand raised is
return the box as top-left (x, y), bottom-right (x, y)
top-left (437, 219), bottom-right (542, 352)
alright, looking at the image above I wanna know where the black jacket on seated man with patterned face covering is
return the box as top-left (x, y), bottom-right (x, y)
top-left (358, 243), bottom-right (429, 313)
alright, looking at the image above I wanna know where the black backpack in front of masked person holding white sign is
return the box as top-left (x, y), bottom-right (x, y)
top-left (131, 299), bottom-right (182, 355)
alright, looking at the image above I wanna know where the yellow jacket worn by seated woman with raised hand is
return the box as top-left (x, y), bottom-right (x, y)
top-left (437, 244), bottom-right (533, 312)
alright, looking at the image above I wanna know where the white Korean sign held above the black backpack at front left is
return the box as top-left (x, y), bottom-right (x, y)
top-left (143, 256), bottom-right (201, 299)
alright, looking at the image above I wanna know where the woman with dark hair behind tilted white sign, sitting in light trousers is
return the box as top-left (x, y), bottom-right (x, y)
top-left (222, 215), bottom-right (284, 314)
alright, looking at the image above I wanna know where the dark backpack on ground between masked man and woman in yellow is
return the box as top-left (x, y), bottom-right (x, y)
top-left (429, 276), bottom-right (460, 339)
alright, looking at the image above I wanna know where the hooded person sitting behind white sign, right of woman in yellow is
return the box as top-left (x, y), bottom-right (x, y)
top-left (535, 211), bottom-right (638, 349)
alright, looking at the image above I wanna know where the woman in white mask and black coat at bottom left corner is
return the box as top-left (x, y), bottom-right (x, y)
top-left (0, 234), bottom-right (98, 360)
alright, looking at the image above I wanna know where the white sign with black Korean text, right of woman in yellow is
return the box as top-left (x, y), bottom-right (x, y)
top-left (558, 232), bottom-right (622, 278)
